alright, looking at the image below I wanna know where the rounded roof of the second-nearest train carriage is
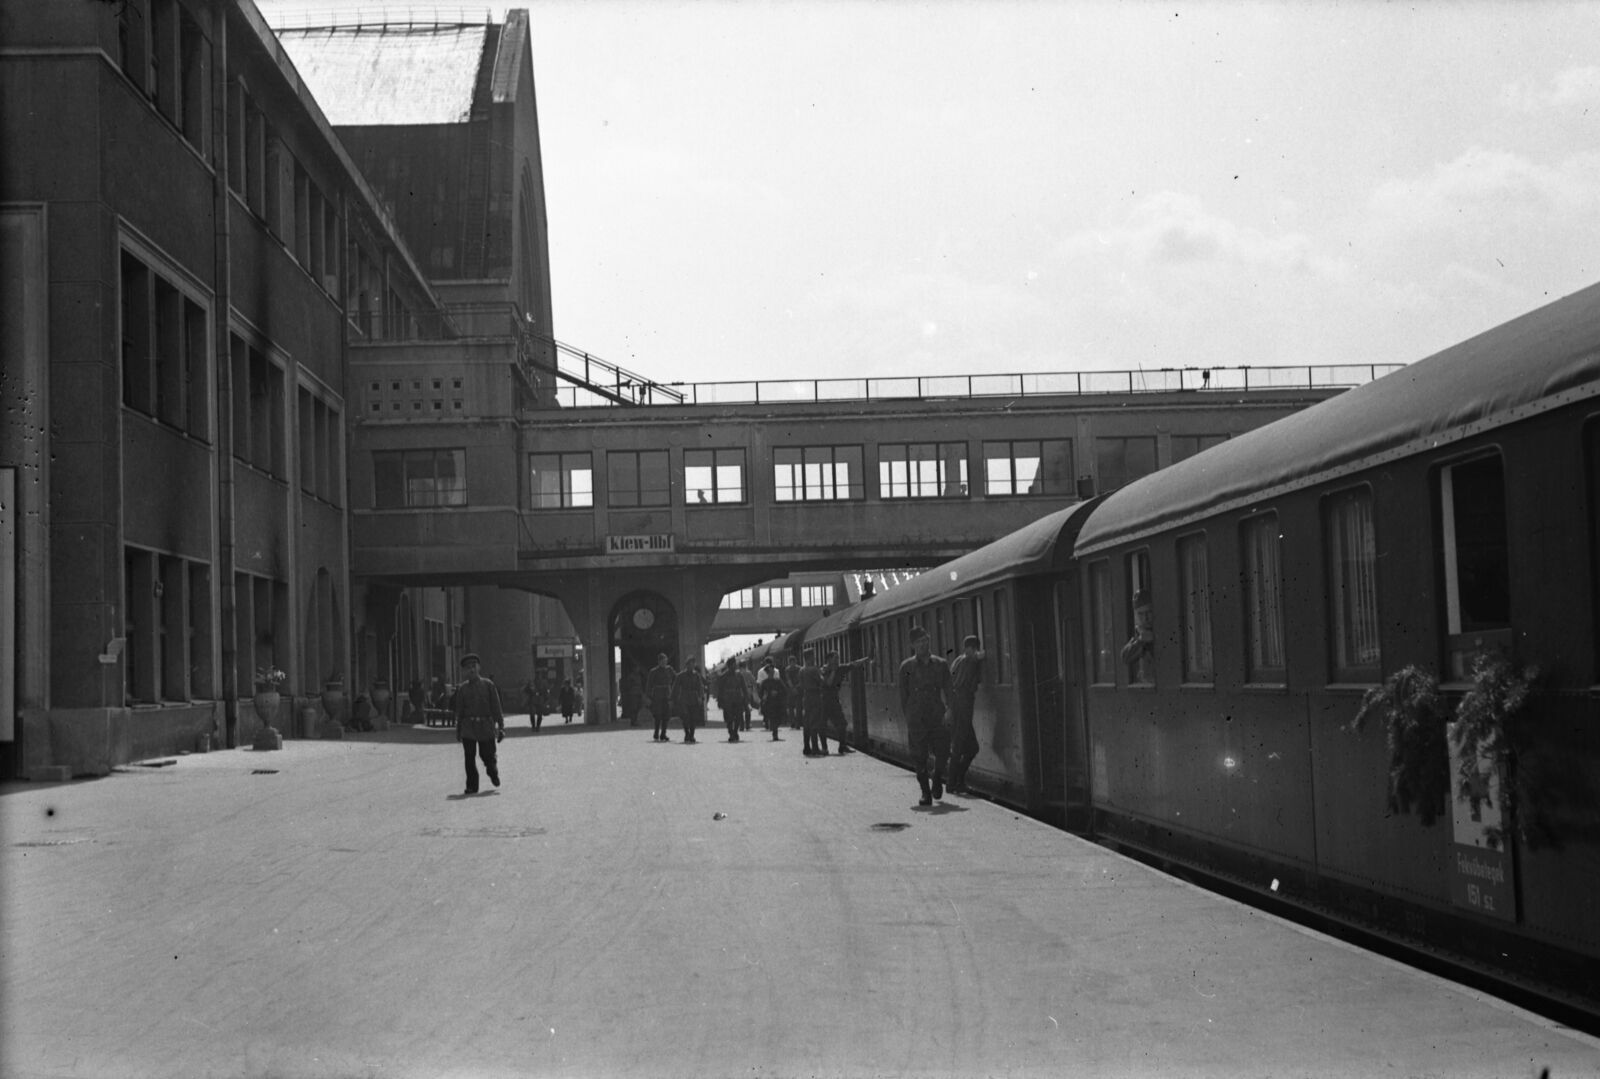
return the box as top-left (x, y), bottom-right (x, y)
top-left (806, 501), bottom-right (1098, 639)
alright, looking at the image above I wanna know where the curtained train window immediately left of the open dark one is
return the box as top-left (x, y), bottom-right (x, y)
top-left (1323, 488), bottom-right (1381, 682)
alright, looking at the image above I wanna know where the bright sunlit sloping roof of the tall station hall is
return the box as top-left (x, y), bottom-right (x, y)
top-left (277, 24), bottom-right (490, 128)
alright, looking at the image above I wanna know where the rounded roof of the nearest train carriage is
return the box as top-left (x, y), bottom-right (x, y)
top-left (1077, 285), bottom-right (1600, 554)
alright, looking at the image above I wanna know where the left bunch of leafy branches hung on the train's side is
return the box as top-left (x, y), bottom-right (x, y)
top-left (1349, 664), bottom-right (1450, 824)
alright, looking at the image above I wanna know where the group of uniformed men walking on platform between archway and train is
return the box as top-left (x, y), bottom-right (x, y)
top-left (622, 628), bottom-right (984, 805)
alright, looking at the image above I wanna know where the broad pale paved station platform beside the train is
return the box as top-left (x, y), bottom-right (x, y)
top-left (9, 711), bottom-right (1600, 1079)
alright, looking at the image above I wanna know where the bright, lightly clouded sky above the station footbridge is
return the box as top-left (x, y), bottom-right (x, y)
top-left (258, 0), bottom-right (1600, 381)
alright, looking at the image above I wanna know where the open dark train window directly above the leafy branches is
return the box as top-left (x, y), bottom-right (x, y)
top-left (1438, 455), bottom-right (1510, 680)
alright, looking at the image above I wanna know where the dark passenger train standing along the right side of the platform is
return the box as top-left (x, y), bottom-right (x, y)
top-left (789, 287), bottom-right (1600, 1015)
